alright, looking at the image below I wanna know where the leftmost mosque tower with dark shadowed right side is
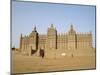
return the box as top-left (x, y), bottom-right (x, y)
top-left (29, 26), bottom-right (38, 50)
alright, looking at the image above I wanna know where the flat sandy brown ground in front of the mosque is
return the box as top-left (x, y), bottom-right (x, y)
top-left (12, 51), bottom-right (96, 73)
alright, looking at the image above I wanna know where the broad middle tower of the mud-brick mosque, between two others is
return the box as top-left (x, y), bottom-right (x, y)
top-left (46, 24), bottom-right (57, 49)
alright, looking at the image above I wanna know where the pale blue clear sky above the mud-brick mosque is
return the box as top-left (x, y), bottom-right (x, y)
top-left (11, 1), bottom-right (96, 48)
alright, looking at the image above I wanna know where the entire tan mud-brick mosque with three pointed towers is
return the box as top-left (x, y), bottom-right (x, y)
top-left (19, 24), bottom-right (95, 58)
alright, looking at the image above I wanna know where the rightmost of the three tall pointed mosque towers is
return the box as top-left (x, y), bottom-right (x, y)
top-left (68, 25), bottom-right (77, 50)
